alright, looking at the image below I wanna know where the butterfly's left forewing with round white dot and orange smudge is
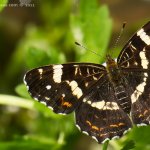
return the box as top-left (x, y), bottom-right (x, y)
top-left (24, 63), bottom-right (105, 114)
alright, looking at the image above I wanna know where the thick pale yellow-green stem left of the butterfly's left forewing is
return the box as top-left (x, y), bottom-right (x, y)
top-left (0, 94), bottom-right (34, 109)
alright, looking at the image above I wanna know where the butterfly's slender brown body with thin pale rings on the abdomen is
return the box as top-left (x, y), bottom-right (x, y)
top-left (106, 55), bottom-right (131, 113)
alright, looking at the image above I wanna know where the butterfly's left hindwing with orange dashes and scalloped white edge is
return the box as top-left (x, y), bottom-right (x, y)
top-left (75, 76), bottom-right (132, 143)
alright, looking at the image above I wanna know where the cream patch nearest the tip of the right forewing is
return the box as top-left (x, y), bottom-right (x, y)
top-left (137, 29), bottom-right (150, 45)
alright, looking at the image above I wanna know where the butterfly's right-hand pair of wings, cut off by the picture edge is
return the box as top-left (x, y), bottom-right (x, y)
top-left (118, 22), bottom-right (150, 125)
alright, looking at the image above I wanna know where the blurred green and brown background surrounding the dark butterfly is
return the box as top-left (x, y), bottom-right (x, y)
top-left (0, 0), bottom-right (150, 150)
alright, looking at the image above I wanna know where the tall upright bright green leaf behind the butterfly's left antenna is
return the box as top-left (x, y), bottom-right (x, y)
top-left (71, 0), bottom-right (112, 63)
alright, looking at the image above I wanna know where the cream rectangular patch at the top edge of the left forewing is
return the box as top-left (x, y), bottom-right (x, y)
top-left (53, 65), bottom-right (63, 83)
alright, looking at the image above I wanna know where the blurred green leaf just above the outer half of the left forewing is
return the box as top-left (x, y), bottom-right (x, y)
top-left (22, 27), bottom-right (65, 68)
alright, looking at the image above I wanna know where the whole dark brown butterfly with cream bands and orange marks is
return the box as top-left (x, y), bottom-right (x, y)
top-left (24, 21), bottom-right (150, 143)
